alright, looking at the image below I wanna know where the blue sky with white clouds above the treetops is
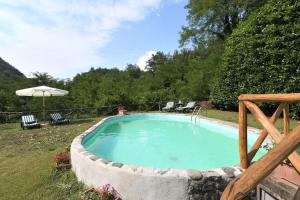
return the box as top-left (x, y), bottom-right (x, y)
top-left (0, 0), bottom-right (187, 78)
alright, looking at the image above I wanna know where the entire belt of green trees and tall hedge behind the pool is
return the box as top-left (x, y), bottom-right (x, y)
top-left (0, 0), bottom-right (300, 117)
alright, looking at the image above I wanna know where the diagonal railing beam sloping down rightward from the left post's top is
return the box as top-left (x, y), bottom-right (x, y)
top-left (244, 101), bottom-right (300, 173)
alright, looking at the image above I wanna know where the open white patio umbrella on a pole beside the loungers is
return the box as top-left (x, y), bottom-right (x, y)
top-left (16, 85), bottom-right (69, 120)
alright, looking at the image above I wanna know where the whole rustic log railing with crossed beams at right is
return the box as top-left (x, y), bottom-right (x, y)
top-left (221, 93), bottom-right (300, 200)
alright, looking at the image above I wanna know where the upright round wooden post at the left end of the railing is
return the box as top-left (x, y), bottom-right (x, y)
top-left (239, 101), bottom-right (249, 169)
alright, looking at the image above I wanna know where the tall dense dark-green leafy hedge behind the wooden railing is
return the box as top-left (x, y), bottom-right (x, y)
top-left (212, 0), bottom-right (300, 114)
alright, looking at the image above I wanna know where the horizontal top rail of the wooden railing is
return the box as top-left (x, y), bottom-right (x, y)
top-left (239, 93), bottom-right (300, 102)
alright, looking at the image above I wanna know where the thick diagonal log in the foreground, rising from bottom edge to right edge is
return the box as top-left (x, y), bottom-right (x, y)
top-left (221, 125), bottom-right (300, 200)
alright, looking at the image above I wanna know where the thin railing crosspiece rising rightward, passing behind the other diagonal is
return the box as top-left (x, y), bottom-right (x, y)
top-left (248, 103), bottom-right (287, 162)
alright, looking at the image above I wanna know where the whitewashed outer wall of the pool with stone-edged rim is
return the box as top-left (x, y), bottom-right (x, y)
top-left (71, 115), bottom-right (246, 200)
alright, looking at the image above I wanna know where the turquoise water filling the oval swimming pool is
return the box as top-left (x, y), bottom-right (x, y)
top-left (82, 114), bottom-right (263, 170)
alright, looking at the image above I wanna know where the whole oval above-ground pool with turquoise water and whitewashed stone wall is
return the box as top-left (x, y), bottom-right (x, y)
top-left (71, 114), bottom-right (264, 200)
